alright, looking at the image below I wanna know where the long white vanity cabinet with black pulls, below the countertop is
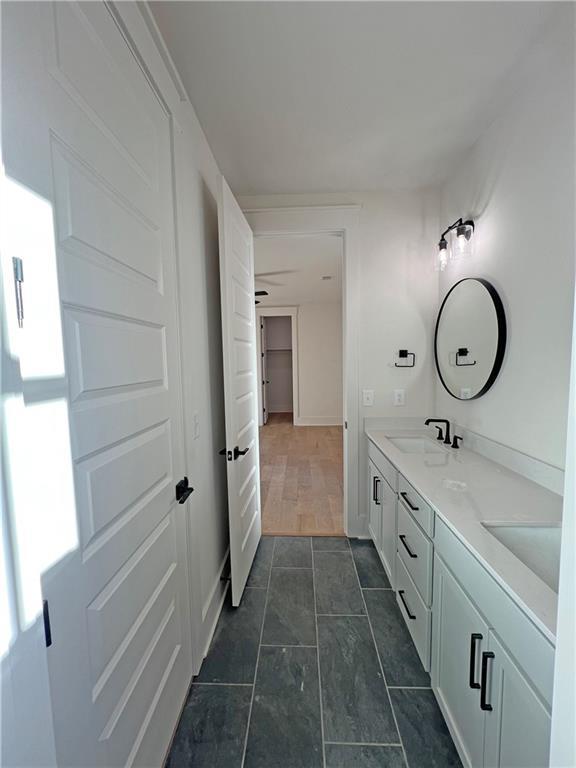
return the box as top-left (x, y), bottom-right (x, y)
top-left (368, 438), bottom-right (554, 768)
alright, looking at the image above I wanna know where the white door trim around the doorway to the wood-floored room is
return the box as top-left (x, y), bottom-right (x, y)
top-left (244, 205), bottom-right (366, 536)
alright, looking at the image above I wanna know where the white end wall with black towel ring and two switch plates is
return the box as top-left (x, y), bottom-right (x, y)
top-left (238, 189), bottom-right (439, 418)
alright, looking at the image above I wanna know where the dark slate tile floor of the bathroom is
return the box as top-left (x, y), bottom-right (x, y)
top-left (167, 537), bottom-right (461, 768)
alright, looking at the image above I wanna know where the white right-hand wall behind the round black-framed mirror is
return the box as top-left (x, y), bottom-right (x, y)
top-left (436, 4), bottom-right (575, 468)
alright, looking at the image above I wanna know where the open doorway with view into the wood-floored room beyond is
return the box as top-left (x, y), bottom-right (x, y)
top-left (254, 233), bottom-right (344, 536)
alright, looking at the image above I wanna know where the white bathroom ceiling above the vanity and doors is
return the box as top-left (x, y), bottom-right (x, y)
top-left (150, 1), bottom-right (554, 194)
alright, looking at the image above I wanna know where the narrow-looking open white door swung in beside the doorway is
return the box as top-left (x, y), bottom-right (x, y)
top-left (218, 177), bottom-right (261, 606)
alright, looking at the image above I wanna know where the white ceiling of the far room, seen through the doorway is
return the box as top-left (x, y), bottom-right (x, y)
top-left (254, 235), bottom-right (342, 307)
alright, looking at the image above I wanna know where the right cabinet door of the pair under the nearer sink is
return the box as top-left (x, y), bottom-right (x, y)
top-left (484, 632), bottom-right (550, 768)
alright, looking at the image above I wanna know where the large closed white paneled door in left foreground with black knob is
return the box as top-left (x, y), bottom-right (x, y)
top-left (3, 2), bottom-right (191, 768)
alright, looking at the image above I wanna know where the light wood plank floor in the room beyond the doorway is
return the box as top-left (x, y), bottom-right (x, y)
top-left (260, 413), bottom-right (344, 536)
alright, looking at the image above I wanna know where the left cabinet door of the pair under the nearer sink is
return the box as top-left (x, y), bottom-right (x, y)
top-left (431, 556), bottom-right (489, 768)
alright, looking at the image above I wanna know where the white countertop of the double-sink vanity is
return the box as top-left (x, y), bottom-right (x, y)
top-left (366, 427), bottom-right (562, 644)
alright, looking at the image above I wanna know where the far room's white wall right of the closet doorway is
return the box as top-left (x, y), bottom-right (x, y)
top-left (298, 302), bottom-right (343, 425)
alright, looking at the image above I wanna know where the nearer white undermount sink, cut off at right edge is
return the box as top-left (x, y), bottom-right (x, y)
top-left (482, 523), bottom-right (561, 593)
